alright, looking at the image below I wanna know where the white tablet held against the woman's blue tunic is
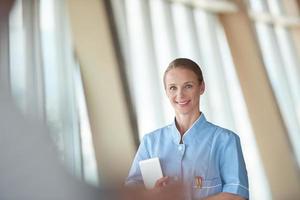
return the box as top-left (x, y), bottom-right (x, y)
top-left (139, 158), bottom-right (163, 189)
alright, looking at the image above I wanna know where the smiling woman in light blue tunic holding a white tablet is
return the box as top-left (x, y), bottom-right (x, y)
top-left (126, 58), bottom-right (249, 200)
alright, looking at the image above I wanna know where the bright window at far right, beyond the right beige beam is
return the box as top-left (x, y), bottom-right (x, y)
top-left (250, 0), bottom-right (300, 167)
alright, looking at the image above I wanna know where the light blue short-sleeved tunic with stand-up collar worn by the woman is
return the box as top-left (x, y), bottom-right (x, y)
top-left (126, 113), bottom-right (249, 199)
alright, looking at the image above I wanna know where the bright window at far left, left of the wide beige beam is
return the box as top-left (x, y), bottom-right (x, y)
top-left (9, 0), bottom-right (98, 184)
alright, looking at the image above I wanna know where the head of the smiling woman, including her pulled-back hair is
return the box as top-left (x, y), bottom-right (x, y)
top-left (164, 59), bottom-right (205, 123)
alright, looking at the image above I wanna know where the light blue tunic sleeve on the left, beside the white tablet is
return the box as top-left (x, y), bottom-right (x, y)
top-left (125, 135), bottom-right (150, 186)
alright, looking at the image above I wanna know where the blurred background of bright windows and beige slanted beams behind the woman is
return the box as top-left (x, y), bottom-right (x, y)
top-left (0, 0), bottom-right (300, 200)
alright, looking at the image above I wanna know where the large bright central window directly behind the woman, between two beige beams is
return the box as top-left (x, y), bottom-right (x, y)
top-left (113, 0), bottom-right (271, 199)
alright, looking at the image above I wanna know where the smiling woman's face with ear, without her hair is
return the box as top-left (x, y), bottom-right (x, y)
top-left (165, 68), bottom-right (205, 114)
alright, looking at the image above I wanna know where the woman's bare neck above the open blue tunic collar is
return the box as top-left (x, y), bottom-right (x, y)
top-left (176, 110), bottom-right (201, 137)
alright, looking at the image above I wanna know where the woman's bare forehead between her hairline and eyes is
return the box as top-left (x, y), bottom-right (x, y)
top-left (165, 67), bottom-right (198, 84)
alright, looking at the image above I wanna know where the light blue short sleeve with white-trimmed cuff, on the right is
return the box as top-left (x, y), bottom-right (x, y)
top-left (220, 132), bottom-right (249, 199)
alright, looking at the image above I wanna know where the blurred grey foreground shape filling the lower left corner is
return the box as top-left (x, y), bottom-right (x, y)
top-left (0, 93), bottom-right (184, 200)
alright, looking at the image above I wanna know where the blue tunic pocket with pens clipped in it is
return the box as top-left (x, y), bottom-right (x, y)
top-left (192, 178), bottom-right (222, 200)
